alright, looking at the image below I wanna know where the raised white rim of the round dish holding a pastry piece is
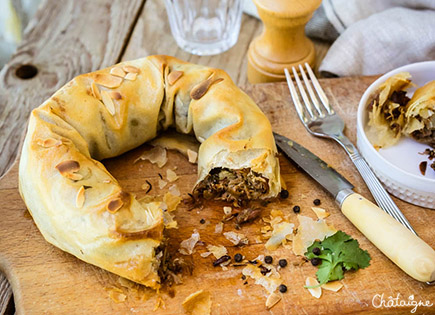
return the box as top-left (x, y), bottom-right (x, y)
top-left (357, 61), bottom-right (435, 185)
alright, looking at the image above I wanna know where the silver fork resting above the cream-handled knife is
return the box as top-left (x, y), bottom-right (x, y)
top-left (285, 63), bottom-right (417, 235)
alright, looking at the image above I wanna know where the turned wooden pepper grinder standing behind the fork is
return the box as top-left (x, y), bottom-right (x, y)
top-left (248, 0), bottom-right (322, 83)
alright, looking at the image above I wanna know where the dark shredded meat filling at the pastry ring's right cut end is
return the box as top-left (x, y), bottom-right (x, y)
top-left (195, 168), bottom-right (269, 206)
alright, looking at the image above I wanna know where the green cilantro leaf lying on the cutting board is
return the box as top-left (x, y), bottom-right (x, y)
top-left (305, 231), bottom-right (371, 285)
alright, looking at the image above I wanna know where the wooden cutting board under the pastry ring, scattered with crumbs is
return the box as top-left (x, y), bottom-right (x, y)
top-left (0, 77), bottom-right (435, 314)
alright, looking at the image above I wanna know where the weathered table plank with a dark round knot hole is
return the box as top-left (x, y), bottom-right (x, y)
top-left (0, 0), bottom-right (144, 176)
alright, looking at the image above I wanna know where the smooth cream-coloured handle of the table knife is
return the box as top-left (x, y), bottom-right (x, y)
top-left (341, 193), bottom-right (435, 282)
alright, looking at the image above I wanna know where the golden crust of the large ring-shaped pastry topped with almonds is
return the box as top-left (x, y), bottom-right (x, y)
top-left (19, 56), bottom-right (281, 288)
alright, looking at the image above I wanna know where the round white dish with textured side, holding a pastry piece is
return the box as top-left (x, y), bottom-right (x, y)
top-left (357, 61), bottom-right (435, 209)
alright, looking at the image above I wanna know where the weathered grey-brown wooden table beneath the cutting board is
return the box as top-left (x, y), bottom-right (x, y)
top-left (0, 0), bottom-right (432, 314)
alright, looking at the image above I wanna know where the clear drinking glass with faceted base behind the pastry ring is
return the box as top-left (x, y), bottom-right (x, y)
top-left (165, 0), bottom-right (243, 56)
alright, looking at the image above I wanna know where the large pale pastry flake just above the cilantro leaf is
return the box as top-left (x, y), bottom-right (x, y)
top-left (293, 215), bottom-right (337, 256)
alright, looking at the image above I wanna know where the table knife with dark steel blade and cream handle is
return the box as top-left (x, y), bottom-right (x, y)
top-left (274, 133), bottom-right (435, 284)
